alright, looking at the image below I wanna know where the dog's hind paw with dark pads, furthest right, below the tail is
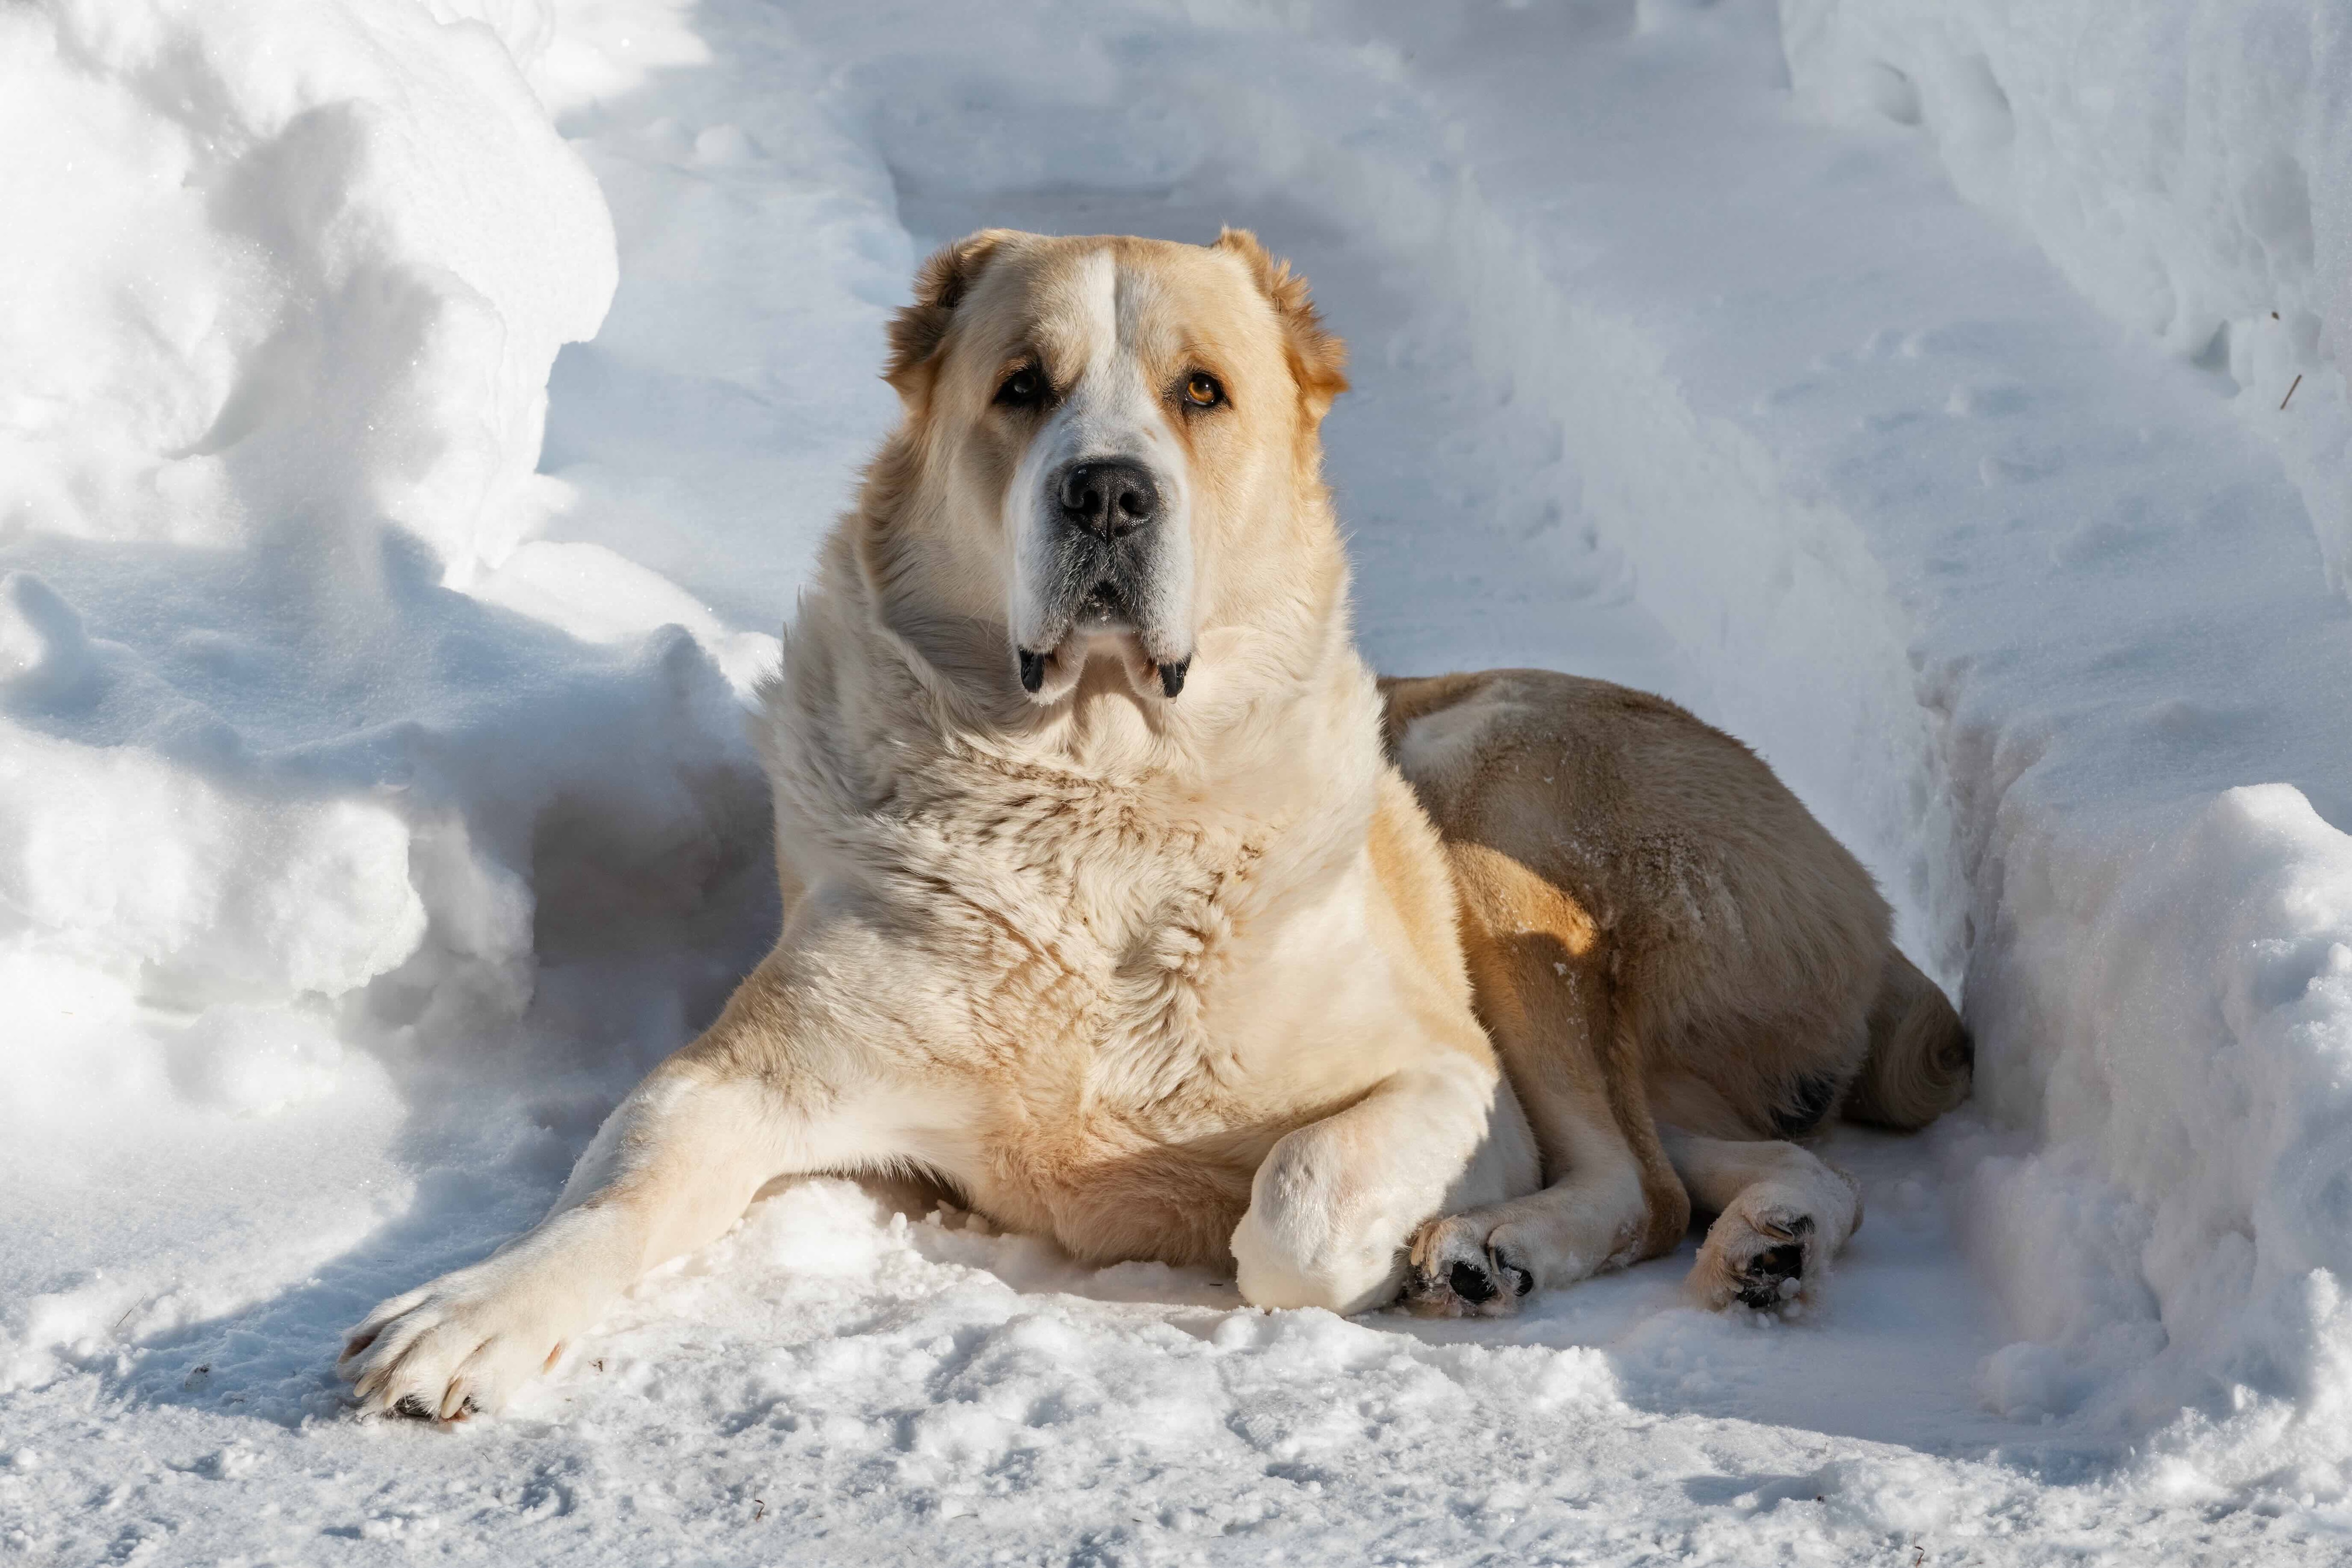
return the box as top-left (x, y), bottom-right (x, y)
top-left (1661, 1126), bottom-right (1863, 1307)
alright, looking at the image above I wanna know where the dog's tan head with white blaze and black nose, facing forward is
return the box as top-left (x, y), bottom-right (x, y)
top-left (861, 230), bottom-right (1345, 705)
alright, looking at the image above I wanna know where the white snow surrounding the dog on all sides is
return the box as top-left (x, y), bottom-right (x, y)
top-left (14, 0), bottom-right (2352, 1563)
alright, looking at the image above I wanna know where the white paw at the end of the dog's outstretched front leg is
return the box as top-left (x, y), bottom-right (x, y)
top-left (334, 1258), bottom-right (569, 1422)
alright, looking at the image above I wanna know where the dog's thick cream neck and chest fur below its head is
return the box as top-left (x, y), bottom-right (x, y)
top-left (762, 557), bottom-right (1385, 1262)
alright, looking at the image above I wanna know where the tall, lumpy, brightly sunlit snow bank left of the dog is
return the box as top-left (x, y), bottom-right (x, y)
top-left (0, 0), bottom-right (762, 1375)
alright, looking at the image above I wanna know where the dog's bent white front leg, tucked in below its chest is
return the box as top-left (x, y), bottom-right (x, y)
top-left (1232, 1053), bottom-right (1536, 1314)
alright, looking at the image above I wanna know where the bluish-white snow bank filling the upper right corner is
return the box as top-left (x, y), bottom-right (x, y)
top-left (1780, 0), bottom-right (2352, 590)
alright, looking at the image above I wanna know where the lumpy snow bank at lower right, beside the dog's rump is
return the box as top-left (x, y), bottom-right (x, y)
top-left (1969, 785), bottom-right (2352, 1481)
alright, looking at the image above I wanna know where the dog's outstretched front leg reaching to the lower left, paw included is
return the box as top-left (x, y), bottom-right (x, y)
top-left (336, 959), bottom-right (903, 1420)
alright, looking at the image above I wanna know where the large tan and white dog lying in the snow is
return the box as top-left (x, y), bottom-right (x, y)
top-left (341, 230), bottom-right (1969, 1420)
